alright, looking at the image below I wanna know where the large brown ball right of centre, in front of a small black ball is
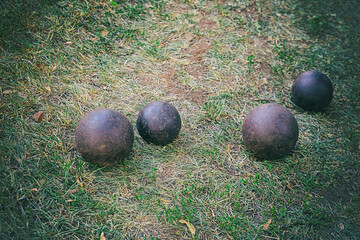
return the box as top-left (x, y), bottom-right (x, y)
top-left (242, 103), bottom-right (299, 159)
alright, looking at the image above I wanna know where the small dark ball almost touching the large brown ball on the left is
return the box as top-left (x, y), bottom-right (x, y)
top-left (136, 101), bottom-right (181, 145)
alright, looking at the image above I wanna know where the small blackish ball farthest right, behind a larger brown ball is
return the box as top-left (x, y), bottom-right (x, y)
top-left (291, 71), bottom-right (334, 111)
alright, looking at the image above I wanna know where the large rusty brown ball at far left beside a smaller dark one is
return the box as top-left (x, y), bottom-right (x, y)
top-left (75, 108), bottom-right (134, 166)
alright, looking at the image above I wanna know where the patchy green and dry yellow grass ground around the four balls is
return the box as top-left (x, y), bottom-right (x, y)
top-left (0, 0), bottom-right (360, 239)
